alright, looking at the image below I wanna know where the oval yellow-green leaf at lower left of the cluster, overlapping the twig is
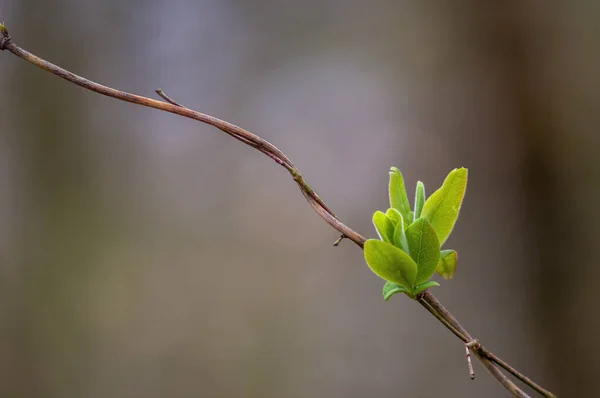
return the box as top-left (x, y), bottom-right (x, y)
top-left (365, 239), bottom-right (417, 288)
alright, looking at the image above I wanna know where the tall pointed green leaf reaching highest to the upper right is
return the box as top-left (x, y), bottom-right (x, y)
top-left (421, 168), bottom-right (467, 245)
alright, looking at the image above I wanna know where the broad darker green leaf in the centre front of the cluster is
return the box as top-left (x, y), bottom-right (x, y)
top-left (406, 218), bottom-right (440, 285)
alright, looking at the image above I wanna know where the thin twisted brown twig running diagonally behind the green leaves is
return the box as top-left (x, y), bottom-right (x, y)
top-left (0, 24), bottom-right (555, 398)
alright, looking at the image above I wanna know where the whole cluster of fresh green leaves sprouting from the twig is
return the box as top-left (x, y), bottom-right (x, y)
top-left (364, 167), bottom-right (467, 301)
